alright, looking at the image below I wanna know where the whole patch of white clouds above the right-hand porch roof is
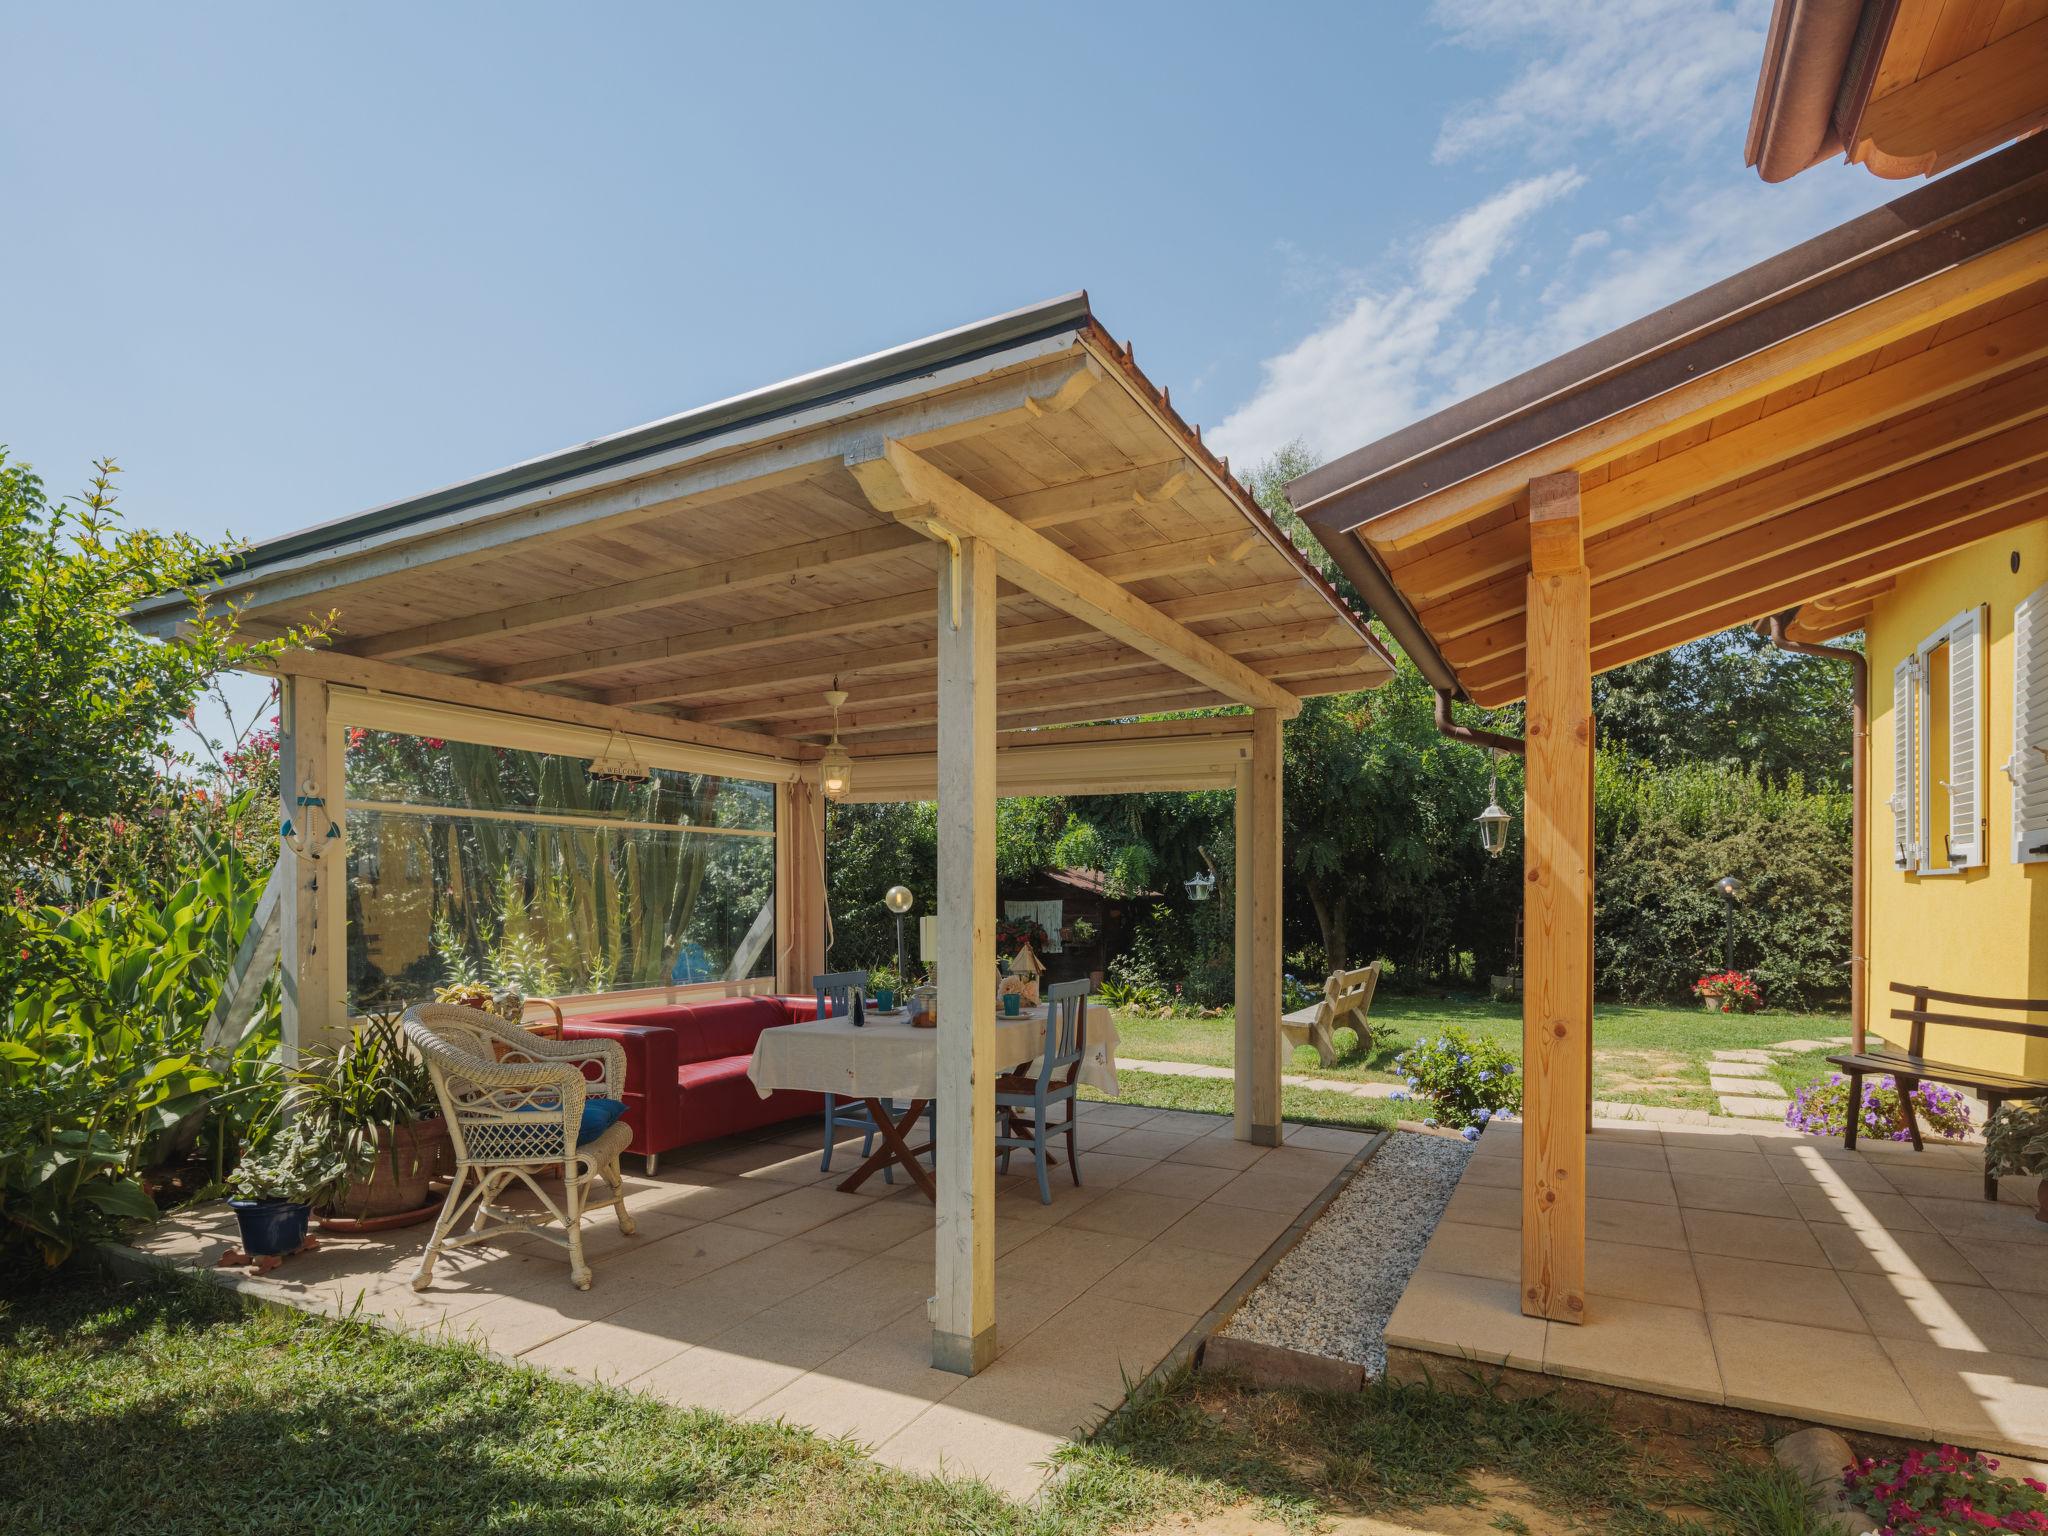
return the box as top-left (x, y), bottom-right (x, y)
top-left (1214, 0), bottom-right (1886, 473)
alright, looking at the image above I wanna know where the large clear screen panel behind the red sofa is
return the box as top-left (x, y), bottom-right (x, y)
top-left (346, 727), bottom-right (774, 1010)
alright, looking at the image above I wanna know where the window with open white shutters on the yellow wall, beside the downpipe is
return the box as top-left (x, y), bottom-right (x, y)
top-left (1890, 608), bottom-right (1985, 874)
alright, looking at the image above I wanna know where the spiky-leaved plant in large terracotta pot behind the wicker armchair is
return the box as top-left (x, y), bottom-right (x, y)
top-left (285, 1014), bottom-right (449, 1231)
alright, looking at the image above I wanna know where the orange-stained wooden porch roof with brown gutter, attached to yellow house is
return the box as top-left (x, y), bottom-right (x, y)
top-left (1290, 139), bottom-right (2048, 705)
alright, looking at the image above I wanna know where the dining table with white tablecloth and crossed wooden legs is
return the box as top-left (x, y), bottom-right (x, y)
top-left (748, 1004), bottom-right (1120, 1200)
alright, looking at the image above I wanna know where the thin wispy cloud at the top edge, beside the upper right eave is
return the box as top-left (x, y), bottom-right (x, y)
top-left (1434, 0), bottom-right (1769, 160)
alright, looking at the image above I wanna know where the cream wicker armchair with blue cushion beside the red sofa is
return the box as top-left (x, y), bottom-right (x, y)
top-left (403, 1004), bottom-right (635, 1290)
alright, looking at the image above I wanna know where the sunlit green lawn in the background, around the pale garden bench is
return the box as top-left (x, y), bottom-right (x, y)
top-left (1116, 993), bottom-right (1849, 1114)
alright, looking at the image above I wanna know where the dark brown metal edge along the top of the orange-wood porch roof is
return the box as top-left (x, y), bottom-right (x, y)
top-left (1288, 135), bottom-right (2048, 532)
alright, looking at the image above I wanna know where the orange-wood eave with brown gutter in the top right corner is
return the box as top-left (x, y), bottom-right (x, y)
top-left (1747, 0), bottom-right (2048, 182)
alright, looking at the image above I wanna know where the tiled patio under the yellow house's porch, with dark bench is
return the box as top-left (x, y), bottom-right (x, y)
top-left (1386, 1126), bottom-right (2048, 1458)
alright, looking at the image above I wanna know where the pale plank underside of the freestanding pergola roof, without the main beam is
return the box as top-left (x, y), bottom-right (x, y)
top-left (216, 324), bottom-right (1391, 752)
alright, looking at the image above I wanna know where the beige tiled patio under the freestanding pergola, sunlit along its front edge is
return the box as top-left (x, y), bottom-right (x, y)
top-left (135, 1102), bottom-right (1368, 1495)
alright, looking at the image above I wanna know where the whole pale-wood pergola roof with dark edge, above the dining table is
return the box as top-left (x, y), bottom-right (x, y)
top-left (137, 295), bottom-right (1391, 756)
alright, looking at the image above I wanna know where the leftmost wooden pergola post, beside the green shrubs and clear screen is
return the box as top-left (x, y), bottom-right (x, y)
top-left (270, 678), bottom-right (348, 1067)
